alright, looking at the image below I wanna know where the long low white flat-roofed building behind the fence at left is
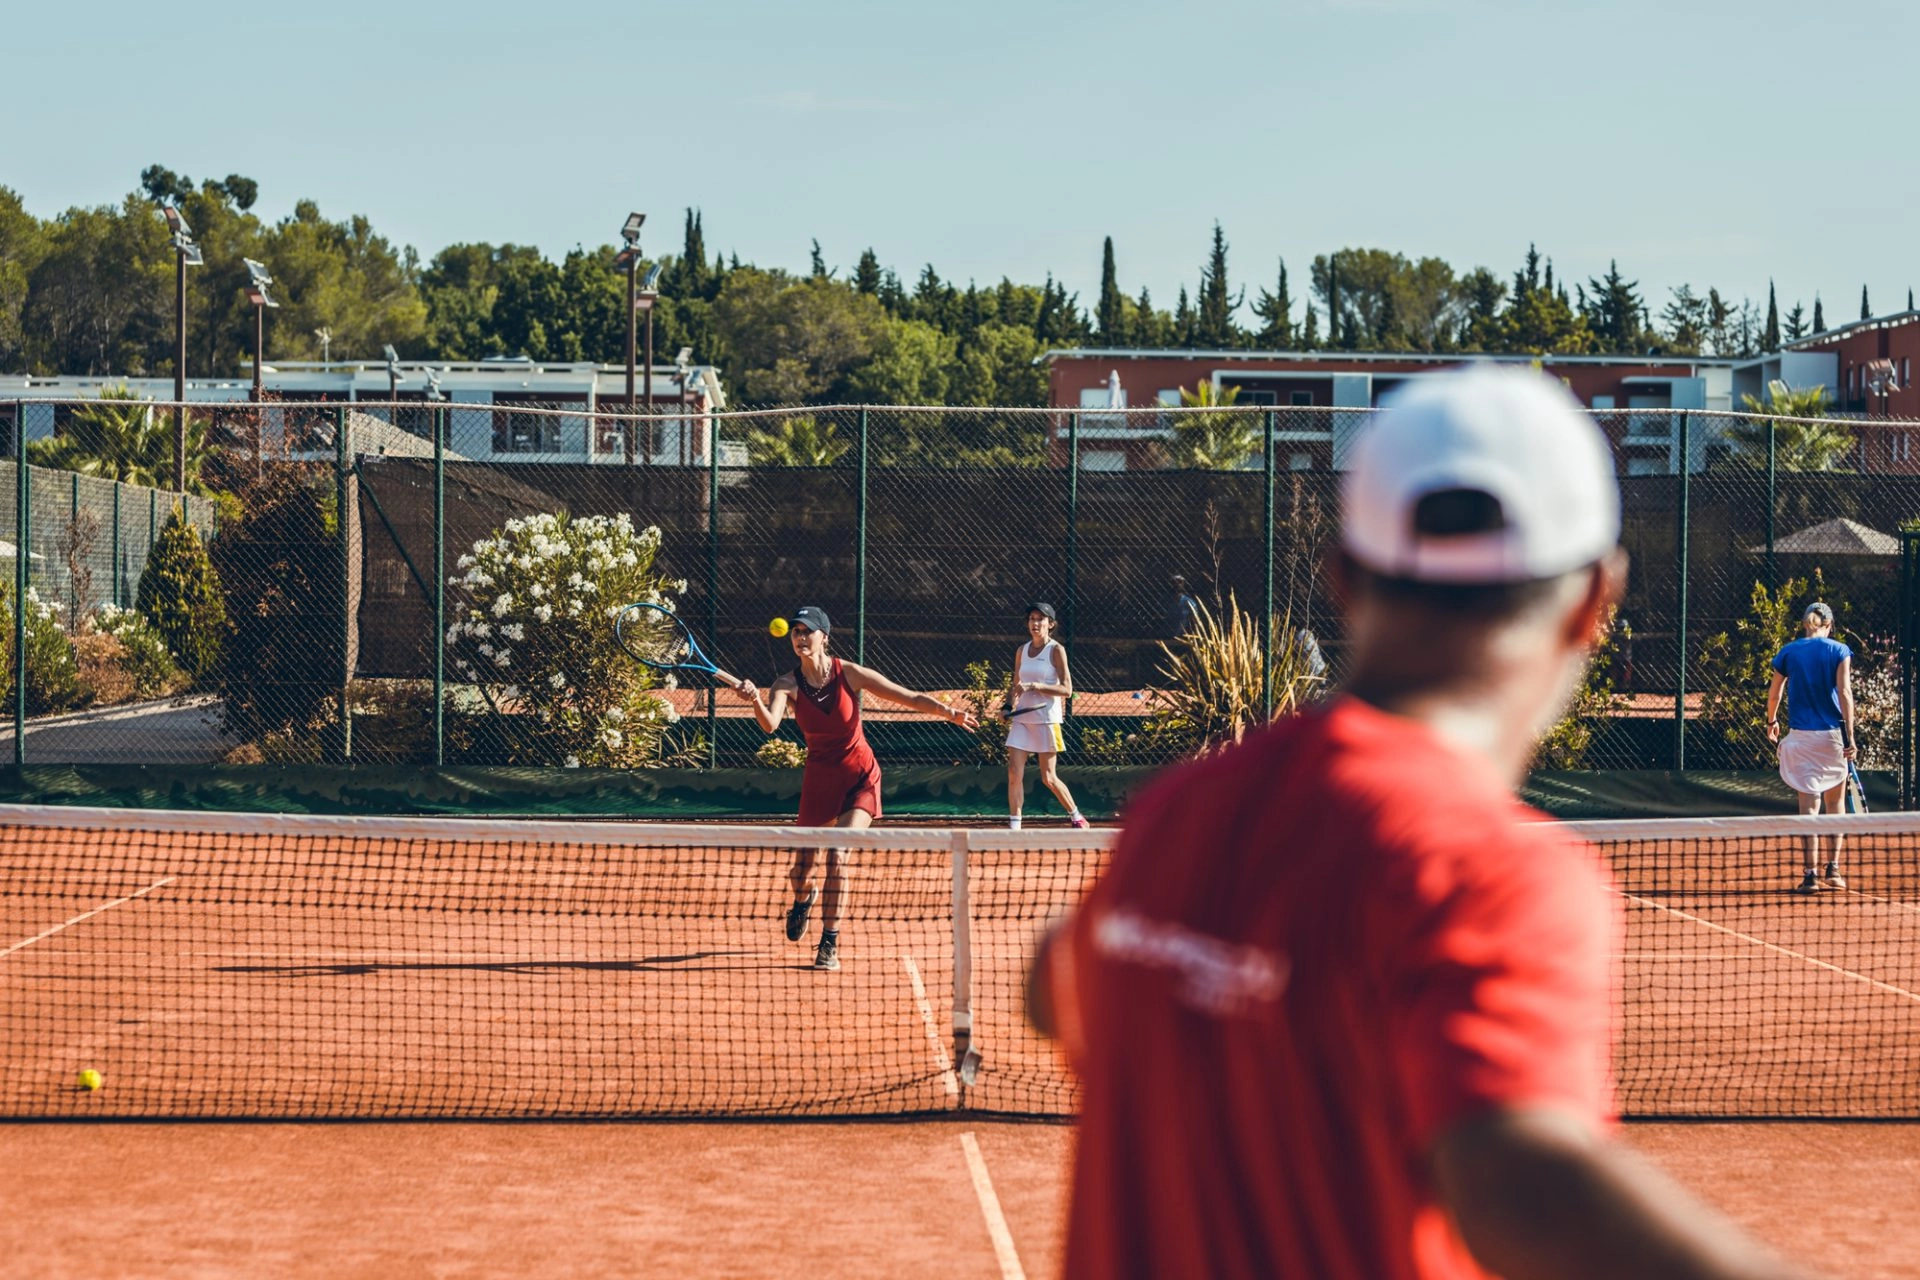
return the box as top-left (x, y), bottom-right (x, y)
top-left (0, 359), bottom-right (725, 466)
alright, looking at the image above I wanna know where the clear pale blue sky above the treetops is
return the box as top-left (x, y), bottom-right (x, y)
top-left (0, 0), bottom-right (1920, 322)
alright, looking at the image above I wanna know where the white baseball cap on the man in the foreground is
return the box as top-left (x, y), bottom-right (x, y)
top-left (1340, 367), bottom-right (1620, 585)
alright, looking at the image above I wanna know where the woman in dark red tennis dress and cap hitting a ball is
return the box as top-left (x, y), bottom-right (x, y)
top-left (735, 604), bottom-right (973, 969)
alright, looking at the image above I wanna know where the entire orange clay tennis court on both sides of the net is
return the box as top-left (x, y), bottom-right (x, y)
top-left (0, 805), bottom-right (1920, 1276)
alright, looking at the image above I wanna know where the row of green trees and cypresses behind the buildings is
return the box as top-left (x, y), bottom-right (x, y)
top-left (0, 165), bottom-right (1889, 405)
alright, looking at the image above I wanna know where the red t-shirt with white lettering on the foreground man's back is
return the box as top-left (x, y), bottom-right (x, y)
top-left (1048, 699), bottom-right (1620, 1280)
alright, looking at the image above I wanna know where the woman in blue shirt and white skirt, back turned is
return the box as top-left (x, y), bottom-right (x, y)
top-left (1766, 604), bottom-right (1853, 894)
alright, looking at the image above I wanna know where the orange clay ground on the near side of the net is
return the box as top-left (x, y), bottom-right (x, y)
top-left (0, 1121), bottom-right (1920, 1280)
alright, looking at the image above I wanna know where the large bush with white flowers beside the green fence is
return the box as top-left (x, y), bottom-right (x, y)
top-left (445, 512), bottom-right (687, 768)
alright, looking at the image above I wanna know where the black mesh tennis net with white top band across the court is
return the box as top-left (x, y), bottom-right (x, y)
top-left (0, 808), bottom-right (1920, 1117)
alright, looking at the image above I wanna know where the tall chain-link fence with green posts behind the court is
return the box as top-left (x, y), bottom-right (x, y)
top-left (0, 401), bottom-right (1920, 782)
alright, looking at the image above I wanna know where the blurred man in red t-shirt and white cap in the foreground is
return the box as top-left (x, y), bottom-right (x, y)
top-left (1033, 370), bottom-right (1799, 1280)
